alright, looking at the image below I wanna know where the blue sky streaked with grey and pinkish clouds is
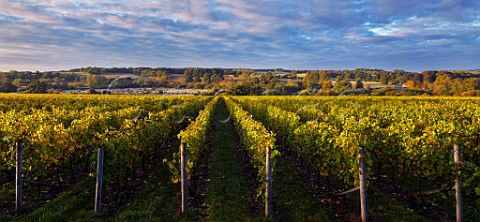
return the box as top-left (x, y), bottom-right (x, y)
top-left (0, 0), bottom-right (480, 71)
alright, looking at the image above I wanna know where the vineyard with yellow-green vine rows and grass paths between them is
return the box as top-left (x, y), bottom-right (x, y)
top-left (0, 95), bottom-right (480, 221)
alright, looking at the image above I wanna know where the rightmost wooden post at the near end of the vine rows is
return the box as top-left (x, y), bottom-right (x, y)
top-left (453, 143), bottom-right (463, 222)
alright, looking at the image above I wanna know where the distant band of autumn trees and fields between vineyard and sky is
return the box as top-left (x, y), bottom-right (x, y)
top-left (0, 67), bottom-right (480, 96)
